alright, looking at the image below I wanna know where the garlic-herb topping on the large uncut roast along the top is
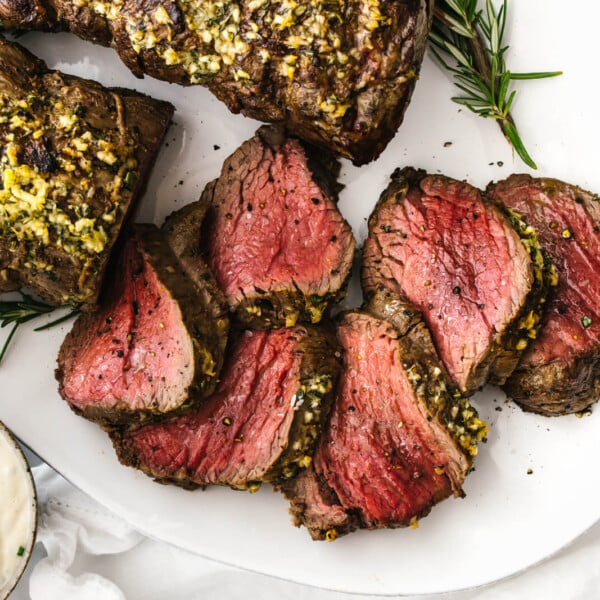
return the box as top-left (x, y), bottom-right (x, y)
top-left (75, 0), bottom-right (392, 119)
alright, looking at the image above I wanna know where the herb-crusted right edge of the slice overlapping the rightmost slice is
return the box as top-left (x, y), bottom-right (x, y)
top-left (474, 203), bottom-right (558, 385)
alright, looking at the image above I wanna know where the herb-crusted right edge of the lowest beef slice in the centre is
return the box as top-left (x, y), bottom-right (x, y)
top-left (364, 289), bottom-right (488, 462)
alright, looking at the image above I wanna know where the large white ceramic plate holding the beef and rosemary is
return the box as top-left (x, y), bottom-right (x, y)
top-left (0, 0), bottom-right (600, 595)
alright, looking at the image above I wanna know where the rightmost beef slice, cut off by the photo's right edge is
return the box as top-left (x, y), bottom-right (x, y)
top-left (487, 175), bottom-right (600, 415)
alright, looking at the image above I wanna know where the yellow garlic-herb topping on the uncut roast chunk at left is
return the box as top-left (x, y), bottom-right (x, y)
top-left (0, 88), bottom-right (137, 303)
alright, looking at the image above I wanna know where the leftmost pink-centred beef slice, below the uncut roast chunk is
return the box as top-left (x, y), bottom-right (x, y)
top-left (56, 224), bottom-right (228, 427)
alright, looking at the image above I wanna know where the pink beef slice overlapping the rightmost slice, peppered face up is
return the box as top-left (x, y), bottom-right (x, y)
top-left (361, 168), bottom-right (548, 393)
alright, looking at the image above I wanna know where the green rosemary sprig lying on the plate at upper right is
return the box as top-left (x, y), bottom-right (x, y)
top-left (429, 0), bottom-right (562, 169)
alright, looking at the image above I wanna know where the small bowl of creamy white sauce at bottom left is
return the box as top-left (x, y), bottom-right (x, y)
top-left (0, 421), bottom-right (37, 600)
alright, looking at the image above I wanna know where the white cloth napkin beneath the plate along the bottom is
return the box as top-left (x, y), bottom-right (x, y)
top-left (11, 465), bottom-right (600, 600)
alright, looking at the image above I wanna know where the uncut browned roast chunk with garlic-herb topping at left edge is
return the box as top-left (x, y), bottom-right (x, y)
top-left (0, 38), bottom-right (173, 309)
